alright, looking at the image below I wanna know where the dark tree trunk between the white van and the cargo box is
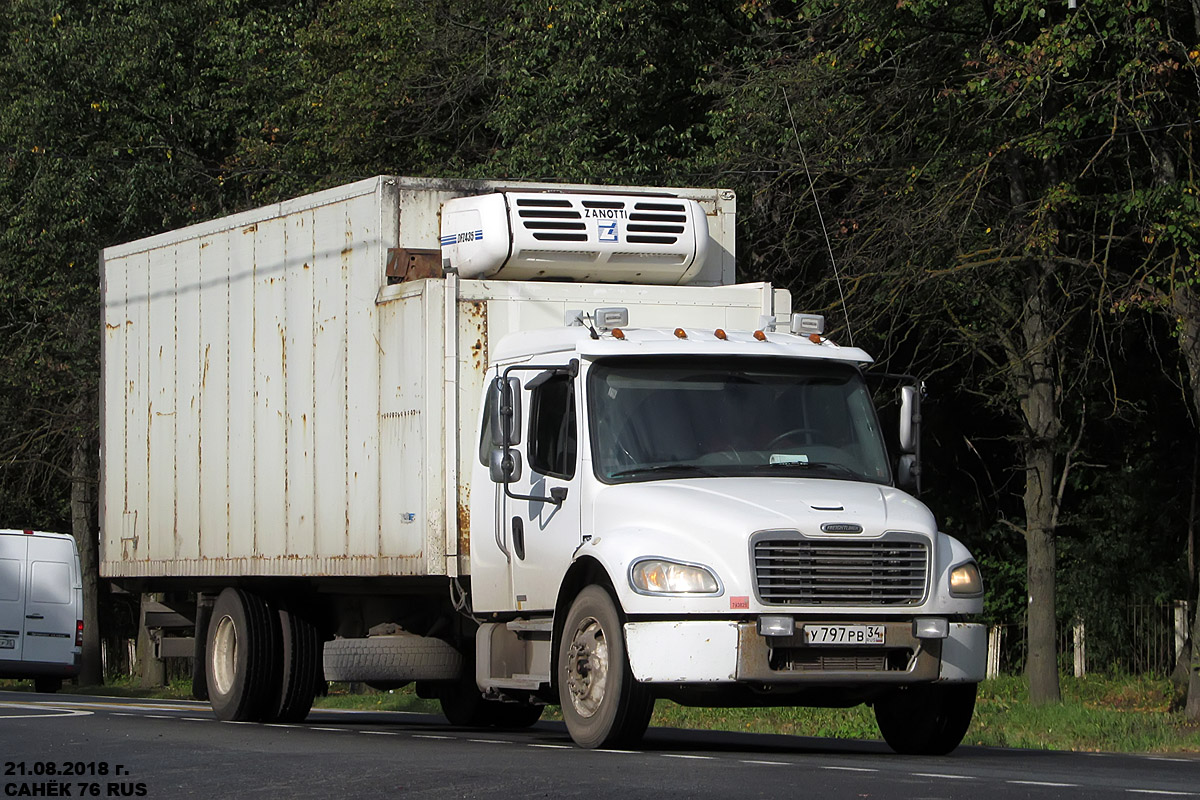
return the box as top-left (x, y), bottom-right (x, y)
top-left (71, 419), bottom-right (104, 686)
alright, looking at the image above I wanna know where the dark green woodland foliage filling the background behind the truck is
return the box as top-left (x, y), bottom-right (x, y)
top-left (0, 0), bottom-right (1200, 700)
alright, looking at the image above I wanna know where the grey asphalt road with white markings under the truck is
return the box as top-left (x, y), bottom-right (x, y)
top-left (0, 692), bottom-right (1200, 800)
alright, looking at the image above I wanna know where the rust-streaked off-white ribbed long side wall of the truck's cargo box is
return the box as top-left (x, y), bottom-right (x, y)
top-left (103, 179), bottom-right (444, 577)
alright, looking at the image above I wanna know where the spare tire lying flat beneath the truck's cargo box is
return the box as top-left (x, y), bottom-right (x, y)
top-left (324, 633), bottom-right (463, 682)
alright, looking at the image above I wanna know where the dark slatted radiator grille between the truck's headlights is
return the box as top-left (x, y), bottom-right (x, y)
top-left (754, 534), bottom-right (929, 606)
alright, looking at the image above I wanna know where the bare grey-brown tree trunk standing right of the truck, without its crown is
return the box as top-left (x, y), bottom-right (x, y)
top-left (1018, 261), bottom-right (1062, 704)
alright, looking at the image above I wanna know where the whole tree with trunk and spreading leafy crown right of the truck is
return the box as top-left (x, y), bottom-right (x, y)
top-left (713, 0), bottom-right (1195, 702)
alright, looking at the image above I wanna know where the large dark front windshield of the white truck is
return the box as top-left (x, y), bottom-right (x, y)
top-left (588, 356), bottom-right (890, 483)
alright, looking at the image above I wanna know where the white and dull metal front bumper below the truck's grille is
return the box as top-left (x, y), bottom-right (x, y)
top-left (625, 620), bottom-right (988, 686)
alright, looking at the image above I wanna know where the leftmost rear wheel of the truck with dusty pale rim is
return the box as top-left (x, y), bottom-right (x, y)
top-left (204, 588), bottom-right (281, 722)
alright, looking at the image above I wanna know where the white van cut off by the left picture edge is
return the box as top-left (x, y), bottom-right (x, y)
top-left (0, 530), bottom-right (83, 692)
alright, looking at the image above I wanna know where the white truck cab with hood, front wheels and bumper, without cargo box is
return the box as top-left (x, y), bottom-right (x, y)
top-left (460, 308), bottom-right (985, 752)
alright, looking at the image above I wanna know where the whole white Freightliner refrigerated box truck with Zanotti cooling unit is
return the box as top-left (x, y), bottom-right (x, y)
top-left (101, 178), bottom-right (986, 753)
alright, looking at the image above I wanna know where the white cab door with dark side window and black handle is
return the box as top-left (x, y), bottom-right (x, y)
top-left (497, 369), bottom-right (581, 612)
